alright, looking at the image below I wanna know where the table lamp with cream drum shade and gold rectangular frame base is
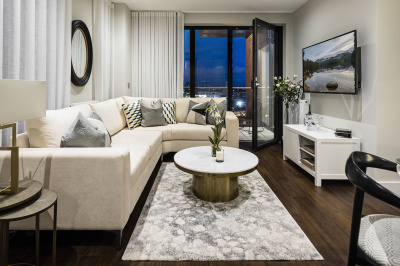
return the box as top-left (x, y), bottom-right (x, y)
top-left (0, 79), bottom-right (46, 194)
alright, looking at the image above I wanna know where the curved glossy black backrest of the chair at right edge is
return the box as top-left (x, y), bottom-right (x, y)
top-left (345, 152), bottom-right (400, 208)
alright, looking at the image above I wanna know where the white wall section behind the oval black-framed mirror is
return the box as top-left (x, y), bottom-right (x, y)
top-left (71, 0), bottom-right (95, 103)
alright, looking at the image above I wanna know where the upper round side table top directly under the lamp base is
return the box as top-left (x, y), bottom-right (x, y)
top-left (0, 180), bottom-right (42, 211)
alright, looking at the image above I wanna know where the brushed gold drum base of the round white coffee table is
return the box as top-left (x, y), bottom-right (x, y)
top-left (192, 175), bottom-right (239, 202)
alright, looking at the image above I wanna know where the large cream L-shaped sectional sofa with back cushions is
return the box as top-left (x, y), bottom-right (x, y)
top-left (0, 97), bottom-right (239, 243)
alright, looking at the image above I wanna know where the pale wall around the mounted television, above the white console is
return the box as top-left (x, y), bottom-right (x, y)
top-left (293, 0), bottom-right (377, 160)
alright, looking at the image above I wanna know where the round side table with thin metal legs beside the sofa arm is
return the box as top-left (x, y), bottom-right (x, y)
top-left (0, 180), bottom-right (57, 266)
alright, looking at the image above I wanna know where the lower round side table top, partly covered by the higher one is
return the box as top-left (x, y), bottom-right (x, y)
top-left (0, 189), bottom-right (57, 222)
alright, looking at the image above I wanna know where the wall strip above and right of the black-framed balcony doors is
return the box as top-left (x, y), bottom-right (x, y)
top-left (185, 13), bottom-right (293, 81)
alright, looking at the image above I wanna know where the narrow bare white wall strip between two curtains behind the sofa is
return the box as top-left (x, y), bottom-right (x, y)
top-left (114, 4), bottom-right (132, 97)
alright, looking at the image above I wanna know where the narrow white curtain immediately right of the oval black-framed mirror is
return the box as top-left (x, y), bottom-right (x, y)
top-left (93, 0), bottom-right (114, 101)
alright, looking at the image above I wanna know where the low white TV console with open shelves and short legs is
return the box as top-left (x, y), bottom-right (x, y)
top-left (283, 125), bottom-right (360, 187)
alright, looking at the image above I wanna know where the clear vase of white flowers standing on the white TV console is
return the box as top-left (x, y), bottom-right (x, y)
top-left (274, 75), bottom-right (303, 124)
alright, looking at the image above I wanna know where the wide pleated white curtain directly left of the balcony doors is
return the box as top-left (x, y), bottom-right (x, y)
top-left (132, 12), bottom-right (184, 98)
